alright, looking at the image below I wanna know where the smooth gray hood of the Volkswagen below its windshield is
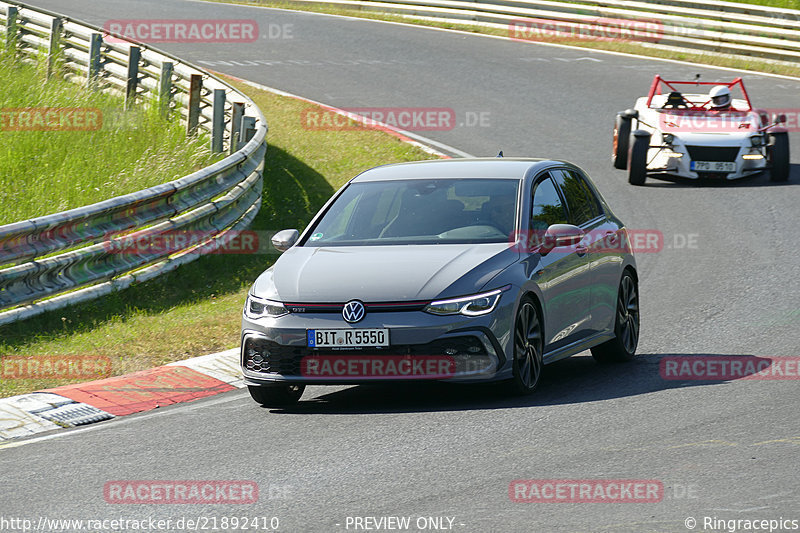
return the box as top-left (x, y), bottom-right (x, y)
top-left (253, 243), bottom-right (519, 303)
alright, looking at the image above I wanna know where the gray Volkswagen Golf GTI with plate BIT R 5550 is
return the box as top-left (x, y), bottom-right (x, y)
top-left (241, 158), bottom-right (639, 406)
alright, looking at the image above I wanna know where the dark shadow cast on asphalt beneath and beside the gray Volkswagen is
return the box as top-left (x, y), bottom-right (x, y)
top-left (260, 354), bottom-right (771, 414)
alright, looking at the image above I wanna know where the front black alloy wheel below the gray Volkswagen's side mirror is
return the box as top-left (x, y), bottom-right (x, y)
top-left (512, 298), bottom-right (544, 394)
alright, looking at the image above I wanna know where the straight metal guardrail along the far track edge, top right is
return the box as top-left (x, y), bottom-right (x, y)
top-left (280, 0), bottom-right (800, 66)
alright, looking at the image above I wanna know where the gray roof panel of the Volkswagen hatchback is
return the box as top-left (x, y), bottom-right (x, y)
top-left (351, 157), bottom-right (573, 183)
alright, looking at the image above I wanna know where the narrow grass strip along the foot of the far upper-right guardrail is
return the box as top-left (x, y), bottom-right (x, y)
top-left (206, 0), bottom-right (800, 77)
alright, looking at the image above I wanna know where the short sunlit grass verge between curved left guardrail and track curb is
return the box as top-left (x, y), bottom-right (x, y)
top-left (0, 76), bottom-right (438, 397)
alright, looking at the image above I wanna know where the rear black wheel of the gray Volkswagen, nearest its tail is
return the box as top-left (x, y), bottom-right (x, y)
top-left (592, 270), bottom-right (639, 363)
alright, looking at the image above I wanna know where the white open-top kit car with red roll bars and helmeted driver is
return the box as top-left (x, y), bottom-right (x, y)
top-left (612, 76), bottom-right (789, 185)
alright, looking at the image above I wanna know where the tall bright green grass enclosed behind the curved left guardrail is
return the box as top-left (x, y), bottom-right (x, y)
top-left (0, 51), bottom-right (219, 225)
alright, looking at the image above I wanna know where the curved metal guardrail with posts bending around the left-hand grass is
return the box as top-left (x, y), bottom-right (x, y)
top-left (0, 1), bottom-right (267, 325)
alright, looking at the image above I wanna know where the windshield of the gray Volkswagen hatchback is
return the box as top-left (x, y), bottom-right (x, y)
top-left (303, 178), bottom-right (519, 246)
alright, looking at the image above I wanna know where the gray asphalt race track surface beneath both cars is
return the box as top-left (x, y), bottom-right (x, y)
top-left (0, 0), bottom-right (800, 533)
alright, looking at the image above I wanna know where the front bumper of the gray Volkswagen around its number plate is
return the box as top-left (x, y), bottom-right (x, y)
top-left (240, 302), bottom-right (512, 385)
